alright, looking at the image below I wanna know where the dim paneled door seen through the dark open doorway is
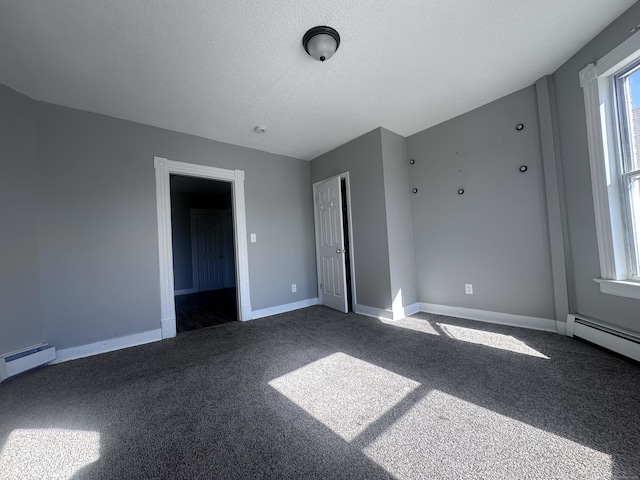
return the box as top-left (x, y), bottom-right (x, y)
top-left (196, 213), bottom-right (224, 291)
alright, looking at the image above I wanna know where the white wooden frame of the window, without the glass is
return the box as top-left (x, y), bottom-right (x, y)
top-left (580, 32), bottom-right (640, 299)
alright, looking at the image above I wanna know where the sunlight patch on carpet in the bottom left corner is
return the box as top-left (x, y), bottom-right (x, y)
top-left (0, 428), bottom-right (100, 480)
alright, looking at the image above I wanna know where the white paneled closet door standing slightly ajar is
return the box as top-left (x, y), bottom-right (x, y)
top-left (315, 177), bottom-right (349, 313)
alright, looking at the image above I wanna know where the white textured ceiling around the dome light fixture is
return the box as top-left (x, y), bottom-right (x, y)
top-left (0, 0), bottom-right (635, 159)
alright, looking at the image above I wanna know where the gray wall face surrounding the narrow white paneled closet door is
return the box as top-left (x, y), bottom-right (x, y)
top-left (311, 128), bottom-right (392, 309)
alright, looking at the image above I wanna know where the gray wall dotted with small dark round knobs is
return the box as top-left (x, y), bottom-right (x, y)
top-left (407, 87), bottom-right (555, 319)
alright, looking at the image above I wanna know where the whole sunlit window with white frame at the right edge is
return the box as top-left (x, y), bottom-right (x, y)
top-left (580, 34), bottom-right (640, 299)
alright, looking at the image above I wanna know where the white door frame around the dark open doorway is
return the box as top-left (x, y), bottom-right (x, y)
top-left (153, 157), bottom-right (253, 338)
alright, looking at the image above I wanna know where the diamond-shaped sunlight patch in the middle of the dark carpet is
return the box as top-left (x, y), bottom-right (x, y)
top-left (269, 353), bottom-right (420, 441)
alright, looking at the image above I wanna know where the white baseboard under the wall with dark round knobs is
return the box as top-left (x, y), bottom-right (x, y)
top-left (420, 303), bottom-right (558, 333)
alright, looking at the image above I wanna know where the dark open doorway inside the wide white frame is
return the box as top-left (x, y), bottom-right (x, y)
top-left (170, 174), bottom-right (238, 333)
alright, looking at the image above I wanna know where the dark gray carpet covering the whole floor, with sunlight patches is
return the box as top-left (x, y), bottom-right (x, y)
top-left (0, 307), bottom-right (640, 479)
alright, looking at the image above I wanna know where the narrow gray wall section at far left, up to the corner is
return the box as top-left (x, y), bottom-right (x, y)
top-left (0, 85), bottom-right (43, 354)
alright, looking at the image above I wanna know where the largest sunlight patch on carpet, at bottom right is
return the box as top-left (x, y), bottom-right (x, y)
top-left (363, 390), bottom-right (612, 480)
